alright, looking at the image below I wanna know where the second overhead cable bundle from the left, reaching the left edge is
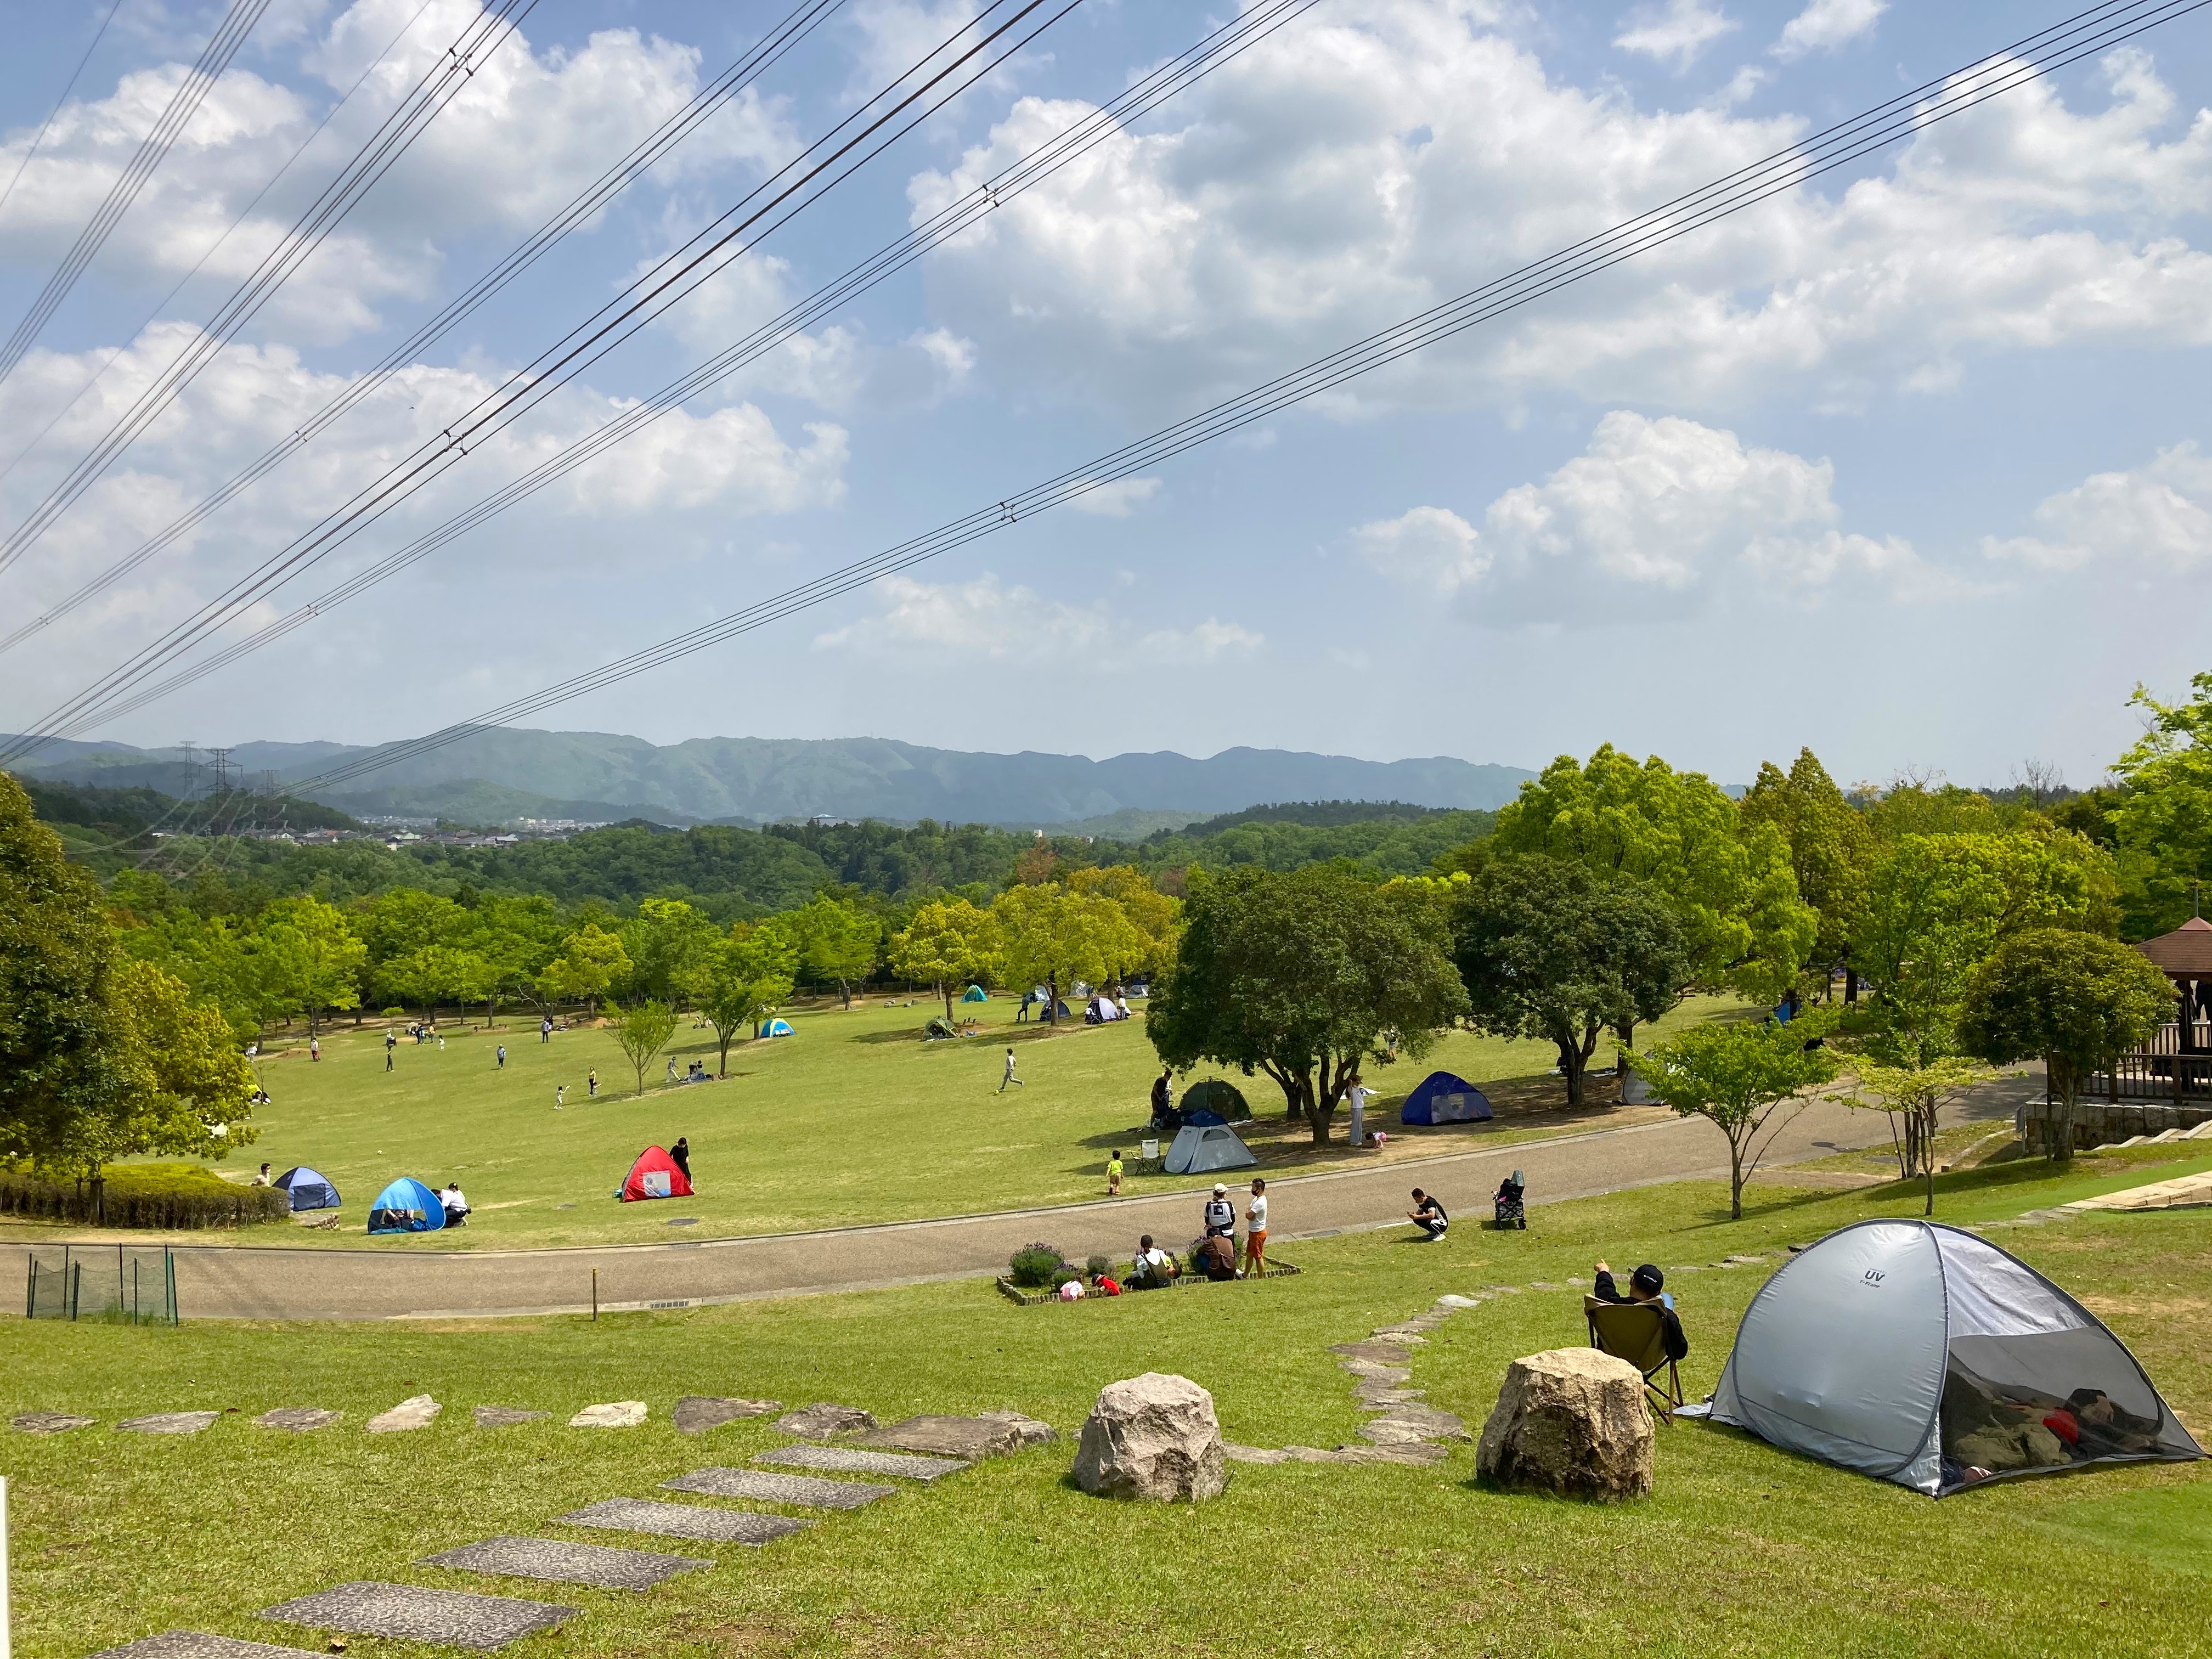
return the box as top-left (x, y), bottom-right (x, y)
top-left (0, 0), bottom-right (538, 571)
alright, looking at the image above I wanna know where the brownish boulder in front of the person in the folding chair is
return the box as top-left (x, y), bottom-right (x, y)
top-left (1475, 1347), bottom-right (1652, 1502)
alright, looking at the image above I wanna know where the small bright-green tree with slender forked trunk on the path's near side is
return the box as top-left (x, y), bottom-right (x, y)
top-left (1626, 1011), bottom-right (1836, 1221)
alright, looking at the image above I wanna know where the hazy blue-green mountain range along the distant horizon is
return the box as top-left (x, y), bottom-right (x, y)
top-left (11, 728), bottom-right (1535, 827)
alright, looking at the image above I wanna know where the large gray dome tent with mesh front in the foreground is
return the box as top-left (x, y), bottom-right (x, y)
top-left (1712, 1221), bottom-right (2203, 1498)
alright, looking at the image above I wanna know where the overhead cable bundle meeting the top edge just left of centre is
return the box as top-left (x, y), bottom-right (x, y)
top-left (4, 0), bottom-right (1084, 747)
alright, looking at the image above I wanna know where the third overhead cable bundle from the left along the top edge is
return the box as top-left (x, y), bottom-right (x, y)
top-left (0, 0), bottom-right (845, 650)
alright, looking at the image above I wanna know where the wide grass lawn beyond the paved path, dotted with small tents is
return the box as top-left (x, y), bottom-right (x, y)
top-left (35, 1000), bottom-right (1734, 1250)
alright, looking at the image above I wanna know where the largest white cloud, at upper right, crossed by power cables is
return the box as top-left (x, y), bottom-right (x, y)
top-left (909, 0), bottom-right (2212, 418)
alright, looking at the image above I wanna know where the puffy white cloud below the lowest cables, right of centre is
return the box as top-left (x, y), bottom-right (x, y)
top-left (1352, 409), bottom-right (1929, 626)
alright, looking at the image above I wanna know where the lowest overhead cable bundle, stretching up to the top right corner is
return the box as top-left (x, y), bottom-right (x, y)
top-left (254, 0), bottom-right (2212, 794)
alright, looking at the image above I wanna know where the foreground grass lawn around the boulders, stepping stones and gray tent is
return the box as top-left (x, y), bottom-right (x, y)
top-left (0, 1159), bottom-right (2212, 1659)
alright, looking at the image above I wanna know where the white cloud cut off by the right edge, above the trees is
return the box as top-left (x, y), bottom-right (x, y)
top-left (1982, 440), bottom-right (2212, 571)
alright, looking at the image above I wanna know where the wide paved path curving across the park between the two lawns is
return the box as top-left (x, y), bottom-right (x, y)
top-left (0, 1077), bottom-right (2040, 1318)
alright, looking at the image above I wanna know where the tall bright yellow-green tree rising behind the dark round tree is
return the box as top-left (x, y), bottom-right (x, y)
top-left (1491, 743), bottom-right (1818, 1026)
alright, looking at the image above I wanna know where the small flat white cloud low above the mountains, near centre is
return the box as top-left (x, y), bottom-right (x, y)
top-left (814, 573), bottom-right (1265, 677)
